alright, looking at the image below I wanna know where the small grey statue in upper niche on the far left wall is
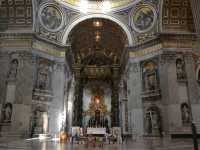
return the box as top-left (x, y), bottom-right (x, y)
top-left (8, 59), bottom-right (19, 79)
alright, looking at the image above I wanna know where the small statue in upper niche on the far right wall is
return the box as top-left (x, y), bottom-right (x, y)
top-left (176, 58), bottom-right (185, 80)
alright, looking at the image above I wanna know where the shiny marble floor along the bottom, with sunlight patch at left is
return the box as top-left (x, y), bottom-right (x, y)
top-left (0, 138), bottom-right (198, 150)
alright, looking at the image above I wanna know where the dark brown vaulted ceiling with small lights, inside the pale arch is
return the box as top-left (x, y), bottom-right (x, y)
top-left (69, 18), bottom-right (127, 65)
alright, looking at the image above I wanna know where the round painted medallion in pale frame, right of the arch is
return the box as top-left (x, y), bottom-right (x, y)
top-left (131, 5), bottom-right (156, 32)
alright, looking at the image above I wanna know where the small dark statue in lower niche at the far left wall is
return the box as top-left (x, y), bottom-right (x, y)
top-left (2, 103), bottom-right (13, 123)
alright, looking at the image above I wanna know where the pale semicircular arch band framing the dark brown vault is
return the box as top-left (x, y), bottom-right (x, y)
top-left (62, 14), bottom-right (134, 46)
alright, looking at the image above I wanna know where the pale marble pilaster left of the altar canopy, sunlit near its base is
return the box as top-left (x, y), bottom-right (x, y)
top-left (49, 62), bottom-right (65, 135)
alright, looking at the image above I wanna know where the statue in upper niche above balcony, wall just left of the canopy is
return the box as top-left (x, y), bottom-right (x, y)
top-left (38, 63), bottom-right (49, 90)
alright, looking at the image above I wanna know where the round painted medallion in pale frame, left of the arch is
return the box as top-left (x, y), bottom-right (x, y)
top-left (40, 5), bottom-right (63, 31)
